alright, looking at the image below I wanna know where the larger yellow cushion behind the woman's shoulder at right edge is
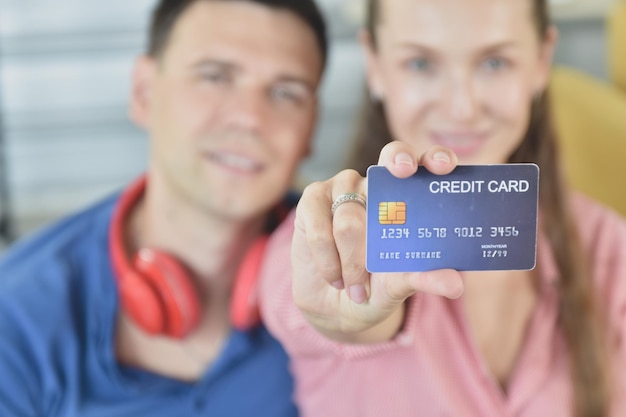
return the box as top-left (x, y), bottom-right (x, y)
top-left (550, 67), bottom-right (626, 216)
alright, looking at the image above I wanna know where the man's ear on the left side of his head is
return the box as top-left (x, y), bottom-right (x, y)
top-left (129, 55), bottom-right (157, 128)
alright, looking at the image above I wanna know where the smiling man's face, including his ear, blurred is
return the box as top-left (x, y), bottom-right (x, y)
top-left (133, 1), bottom-right (322, 219)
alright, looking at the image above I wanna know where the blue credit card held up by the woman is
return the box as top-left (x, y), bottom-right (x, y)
top-left (366, 164), bottom-right (539, 272)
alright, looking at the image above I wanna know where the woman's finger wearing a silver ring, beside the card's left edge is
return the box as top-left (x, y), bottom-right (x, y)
top-left (326, 170), bottom-right (369, 304)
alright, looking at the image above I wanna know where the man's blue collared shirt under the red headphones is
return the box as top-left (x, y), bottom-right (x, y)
top-left (0, 196), bottom-right (297, 417)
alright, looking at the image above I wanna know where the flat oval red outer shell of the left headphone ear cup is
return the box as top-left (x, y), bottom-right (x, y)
top-left (118, 269), bottom-right (165, 334)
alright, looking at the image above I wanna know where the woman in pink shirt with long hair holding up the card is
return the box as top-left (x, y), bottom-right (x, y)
top-left (264, 0), bottom-right (626, 416)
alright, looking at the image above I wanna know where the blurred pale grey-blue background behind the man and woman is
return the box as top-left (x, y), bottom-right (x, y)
top-left (0, 0), bottom-right (626, 247)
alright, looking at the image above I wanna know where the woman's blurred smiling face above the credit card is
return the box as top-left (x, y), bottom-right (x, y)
top-left (364, 0), bottom-right (556, 164)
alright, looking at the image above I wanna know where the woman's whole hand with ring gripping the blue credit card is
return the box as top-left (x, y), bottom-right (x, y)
top-left (289, 142), bottom-right (463, 343)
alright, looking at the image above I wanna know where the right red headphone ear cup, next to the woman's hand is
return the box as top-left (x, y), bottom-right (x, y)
top-left (230, 235), bottom-right (268, 330)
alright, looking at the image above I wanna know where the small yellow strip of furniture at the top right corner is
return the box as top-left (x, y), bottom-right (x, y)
top-left (606, 0), bottom-right (626, 92)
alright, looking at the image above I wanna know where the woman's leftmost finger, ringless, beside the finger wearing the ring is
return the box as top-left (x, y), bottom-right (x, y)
top-left (292, 180), bottom-right (343, 284)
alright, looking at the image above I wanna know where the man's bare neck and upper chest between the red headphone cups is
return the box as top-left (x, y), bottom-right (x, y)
top-left (116, 177), bottom-right (267, 380)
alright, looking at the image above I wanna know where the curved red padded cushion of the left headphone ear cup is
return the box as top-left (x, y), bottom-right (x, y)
top-left (133, 248), bottom-right (200, 339)
